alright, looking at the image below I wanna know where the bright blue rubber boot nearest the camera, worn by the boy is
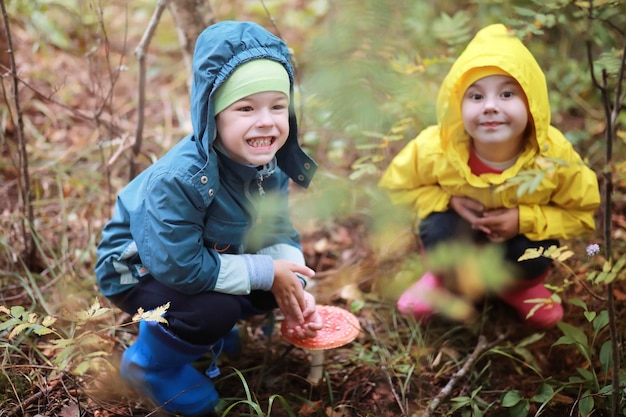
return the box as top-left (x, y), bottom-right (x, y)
top-left (120, 320), bottom-right (219, 417)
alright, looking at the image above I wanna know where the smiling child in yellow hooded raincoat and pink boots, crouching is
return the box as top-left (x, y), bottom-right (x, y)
top-left (379, 24), bottom-right (600, 328)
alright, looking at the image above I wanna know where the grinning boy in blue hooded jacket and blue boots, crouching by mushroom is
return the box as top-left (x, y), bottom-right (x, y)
top-left (95, 22), bottom-right (321, 416)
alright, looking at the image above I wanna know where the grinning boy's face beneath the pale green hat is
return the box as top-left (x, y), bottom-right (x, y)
top-left (215, 91), bottom-right (289, 166)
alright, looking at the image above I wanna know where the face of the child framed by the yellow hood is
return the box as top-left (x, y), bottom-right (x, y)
top-left (461, 75), bottom-right (529, 157)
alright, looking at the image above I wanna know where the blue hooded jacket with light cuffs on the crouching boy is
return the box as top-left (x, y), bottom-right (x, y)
top-left (95, 21), bottom-right (317, 296)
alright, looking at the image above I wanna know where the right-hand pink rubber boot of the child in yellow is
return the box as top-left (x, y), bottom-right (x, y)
top-left (498, 273), bottom-right (563, 329)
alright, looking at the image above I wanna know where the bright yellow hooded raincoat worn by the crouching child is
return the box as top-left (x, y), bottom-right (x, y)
top-left (379, 24), bottom-right (600, 240)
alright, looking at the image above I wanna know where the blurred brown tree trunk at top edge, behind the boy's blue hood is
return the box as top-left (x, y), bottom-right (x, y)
top-left (168, 0), bottom-right (215, 86)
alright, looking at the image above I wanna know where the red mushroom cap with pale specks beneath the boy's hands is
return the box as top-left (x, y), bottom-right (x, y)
top-left (281, 305), bottom-right (361, 350)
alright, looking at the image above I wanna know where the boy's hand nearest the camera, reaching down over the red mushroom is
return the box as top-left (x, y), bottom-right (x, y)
top-left (271, 260), bottom-right (315, 326)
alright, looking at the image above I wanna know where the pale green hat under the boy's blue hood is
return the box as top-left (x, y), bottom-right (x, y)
top-left (215, 59), bottom-right (290, 115)
